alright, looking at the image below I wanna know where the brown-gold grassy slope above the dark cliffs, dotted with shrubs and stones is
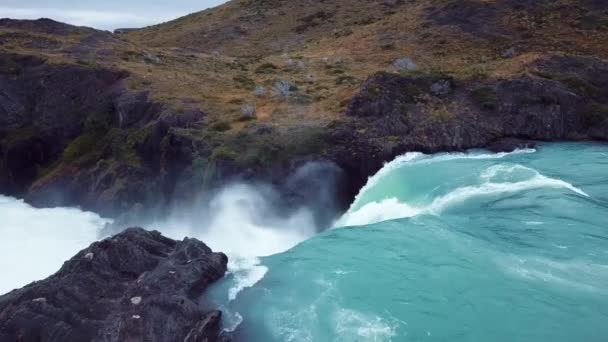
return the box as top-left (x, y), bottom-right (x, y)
top-left (1, 0), bottom-right (608, 136)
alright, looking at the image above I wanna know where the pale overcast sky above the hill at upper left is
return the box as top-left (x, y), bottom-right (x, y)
top-left (0, 0), bottom-right (226, 30)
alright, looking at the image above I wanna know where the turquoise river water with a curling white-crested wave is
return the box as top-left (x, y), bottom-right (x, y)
top-left (208, 144), bottom-right (608, 341)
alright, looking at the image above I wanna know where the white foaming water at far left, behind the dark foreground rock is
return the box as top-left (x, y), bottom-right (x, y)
top-left (0, 195), bottom-right (110, 294)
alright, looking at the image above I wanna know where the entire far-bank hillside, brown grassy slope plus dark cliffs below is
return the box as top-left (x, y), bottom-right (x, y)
top-left (0, 0), bottom-right (608, 223)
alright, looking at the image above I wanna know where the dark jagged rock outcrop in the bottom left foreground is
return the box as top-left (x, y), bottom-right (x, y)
top-left (0, 228), bottom-right (228, 342)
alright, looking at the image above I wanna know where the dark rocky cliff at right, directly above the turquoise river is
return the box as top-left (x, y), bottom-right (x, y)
top-left (342, 57), bottom-right (608, 154)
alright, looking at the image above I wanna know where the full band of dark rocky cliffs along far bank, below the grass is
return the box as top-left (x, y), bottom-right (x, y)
top-left (0, 50), bottom-right (608, 224)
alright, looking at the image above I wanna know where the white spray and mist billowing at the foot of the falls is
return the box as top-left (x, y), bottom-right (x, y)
top-left (154, 184), bottom-right (316, 301)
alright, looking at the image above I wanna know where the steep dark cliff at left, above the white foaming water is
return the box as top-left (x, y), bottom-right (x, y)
top-left (0, 54), bottom-right (192, 218)
